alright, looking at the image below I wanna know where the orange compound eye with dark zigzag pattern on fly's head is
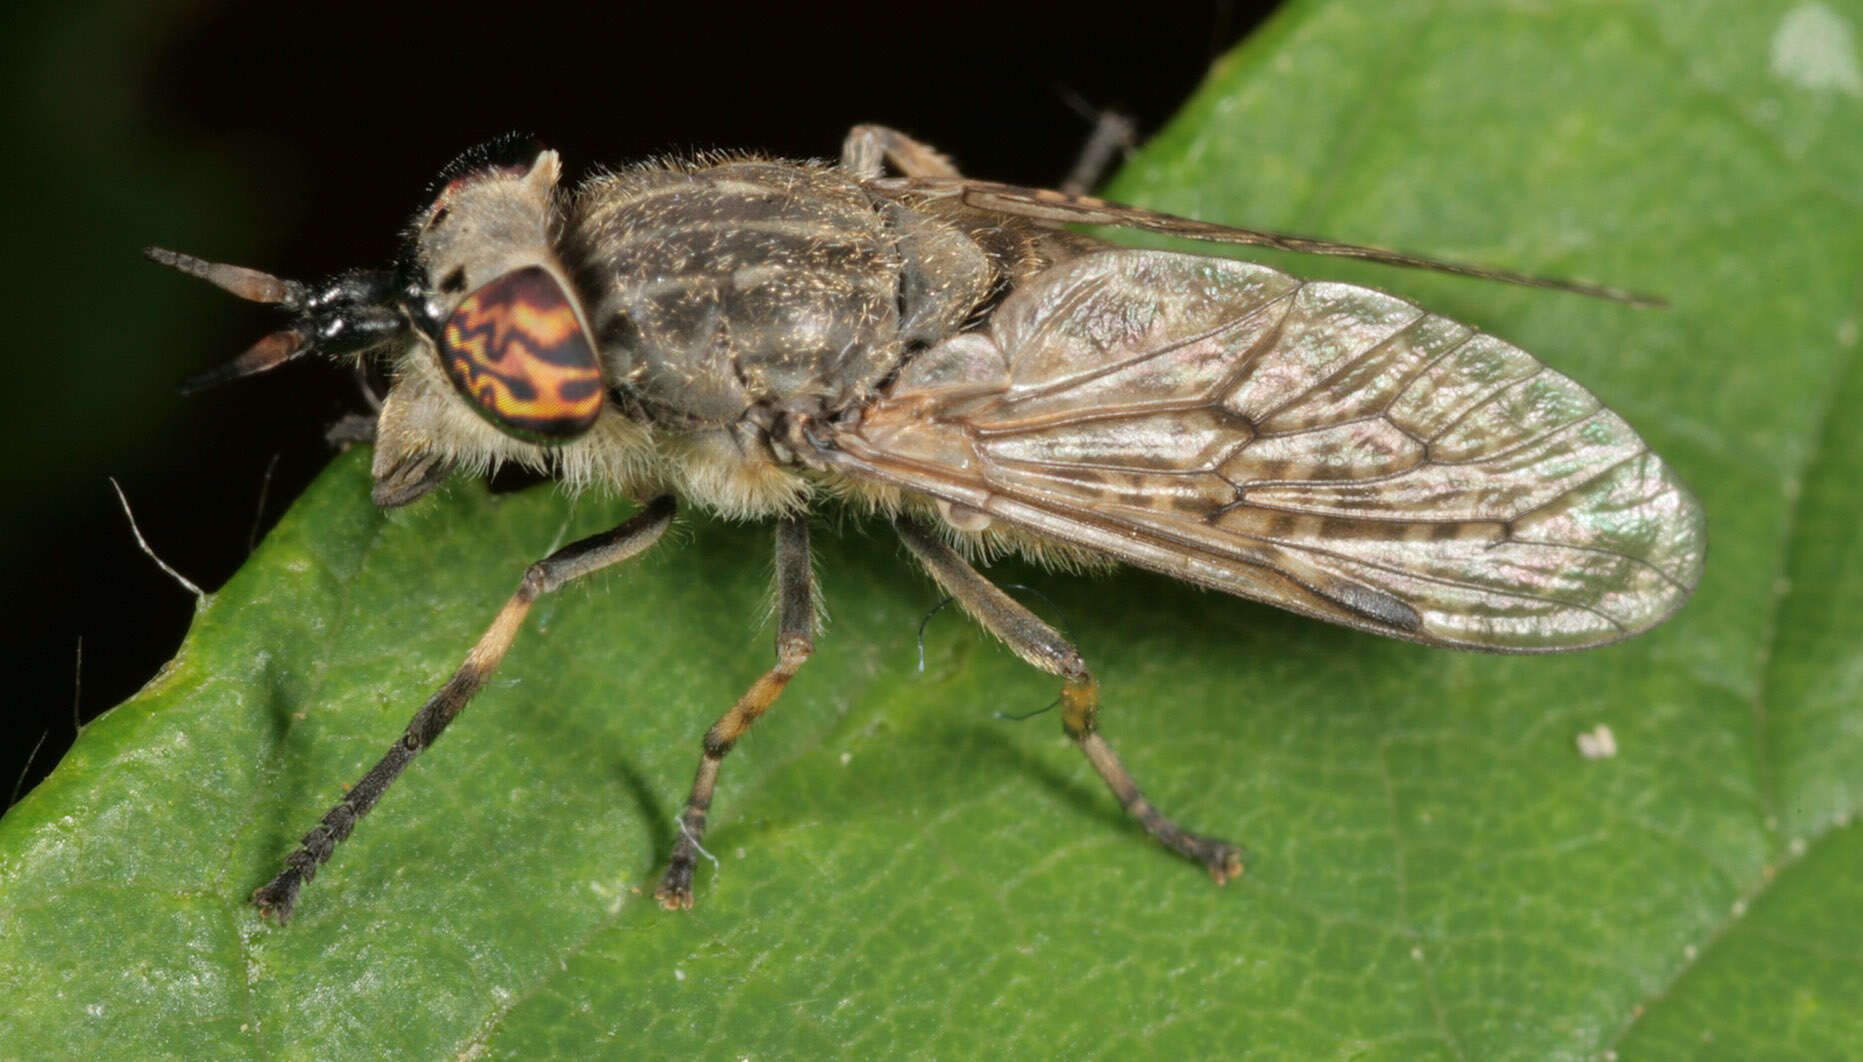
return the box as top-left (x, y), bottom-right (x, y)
top-left (440, 266), bottom-right (602, 442)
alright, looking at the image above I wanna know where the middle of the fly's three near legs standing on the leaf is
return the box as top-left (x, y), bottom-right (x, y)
top-left (654, 516), bottom-right (816, 911)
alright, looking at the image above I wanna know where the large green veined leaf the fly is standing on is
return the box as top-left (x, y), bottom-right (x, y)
top-left (0, 0), bottom-right (1863, 1058)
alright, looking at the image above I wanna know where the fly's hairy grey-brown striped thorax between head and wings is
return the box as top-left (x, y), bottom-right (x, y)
top-left (563, 158), bottom-right (997, 514)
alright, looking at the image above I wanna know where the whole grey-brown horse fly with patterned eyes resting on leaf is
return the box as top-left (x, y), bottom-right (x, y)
top-left (149, 127), bottom-right (1703, 920)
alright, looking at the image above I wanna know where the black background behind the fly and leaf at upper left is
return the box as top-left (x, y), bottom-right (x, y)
top-left (0, 0), bottom-right (1271, 799)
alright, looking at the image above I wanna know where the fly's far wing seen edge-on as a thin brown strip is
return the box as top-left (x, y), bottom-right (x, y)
top-left (870, 177), bottom-right (1667, 306)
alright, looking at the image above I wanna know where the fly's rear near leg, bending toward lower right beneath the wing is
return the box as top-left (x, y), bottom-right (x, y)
top-left (894, 516), bottom-right (1243, 883)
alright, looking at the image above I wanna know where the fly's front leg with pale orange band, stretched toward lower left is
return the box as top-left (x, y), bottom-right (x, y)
top-left (252, 496), bottom-right (674, 922)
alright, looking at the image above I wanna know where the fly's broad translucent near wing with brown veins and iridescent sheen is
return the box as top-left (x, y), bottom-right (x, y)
top-left (823, 250), bottom-right (1705, 652)
